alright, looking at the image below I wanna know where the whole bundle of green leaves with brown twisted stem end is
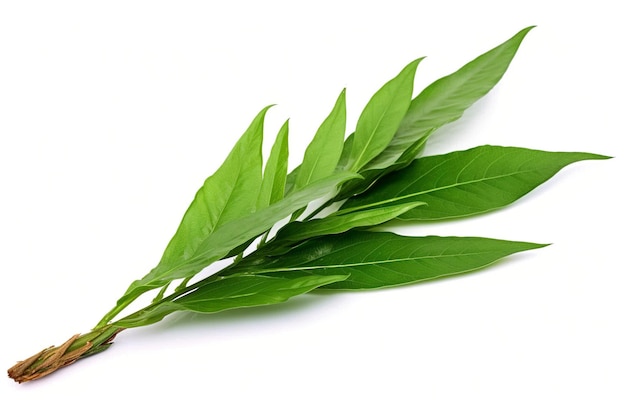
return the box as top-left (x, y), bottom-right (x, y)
top-left (8, 27), bottom-right (607, 383)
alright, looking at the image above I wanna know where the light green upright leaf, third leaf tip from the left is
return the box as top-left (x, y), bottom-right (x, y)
top-left (295, 89), bottom-right (346, 190)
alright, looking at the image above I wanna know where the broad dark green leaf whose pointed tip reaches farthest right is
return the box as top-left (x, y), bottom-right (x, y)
top-left (342, 146), bottom-right (607, 220)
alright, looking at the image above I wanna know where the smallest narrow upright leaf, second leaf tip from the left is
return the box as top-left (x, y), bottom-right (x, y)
top-left (257, 120), bottom-right (289, 210)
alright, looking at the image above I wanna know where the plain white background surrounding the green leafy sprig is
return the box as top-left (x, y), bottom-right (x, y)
top-left (0, 0), bottom-right (626, 416)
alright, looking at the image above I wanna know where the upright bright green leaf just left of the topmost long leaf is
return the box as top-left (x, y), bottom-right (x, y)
top-left (347, 58), bottom-right (422, 172)
